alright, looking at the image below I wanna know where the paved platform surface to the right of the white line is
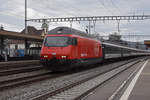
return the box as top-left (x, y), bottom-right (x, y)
top-left (125, 59), bottom-right (150, 100)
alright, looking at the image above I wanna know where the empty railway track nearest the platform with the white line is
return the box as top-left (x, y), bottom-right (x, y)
top-left (33, 56), bottom-right (147, 100)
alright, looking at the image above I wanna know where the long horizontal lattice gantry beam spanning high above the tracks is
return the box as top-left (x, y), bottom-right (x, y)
top-left (27, 15), bottom-right (150, 23)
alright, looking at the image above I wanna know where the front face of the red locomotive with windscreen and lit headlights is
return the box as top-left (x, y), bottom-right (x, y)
top-left (40, 35), bottom-right (77, 71)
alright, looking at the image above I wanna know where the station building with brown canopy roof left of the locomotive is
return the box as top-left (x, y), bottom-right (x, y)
top-left (0, 26), bottom-right (44, 57)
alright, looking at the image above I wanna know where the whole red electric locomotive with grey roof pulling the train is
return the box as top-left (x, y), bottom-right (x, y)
top-left (40, 27), bottom-right (103, 71)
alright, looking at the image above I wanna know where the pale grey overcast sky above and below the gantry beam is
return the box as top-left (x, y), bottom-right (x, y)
top-left (0, 0), bottom-right (150, 39)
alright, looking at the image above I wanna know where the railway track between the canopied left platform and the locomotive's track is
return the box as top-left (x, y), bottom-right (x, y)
top-left (0, 60), bottom-right (43, 76)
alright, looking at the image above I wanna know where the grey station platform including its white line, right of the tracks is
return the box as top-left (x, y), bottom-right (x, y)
top-left (84, 58), bottom-right (150, 100)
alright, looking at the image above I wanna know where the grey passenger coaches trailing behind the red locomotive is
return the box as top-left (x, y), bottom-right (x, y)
top-left (102, 42), bottom-right (150, 60)
